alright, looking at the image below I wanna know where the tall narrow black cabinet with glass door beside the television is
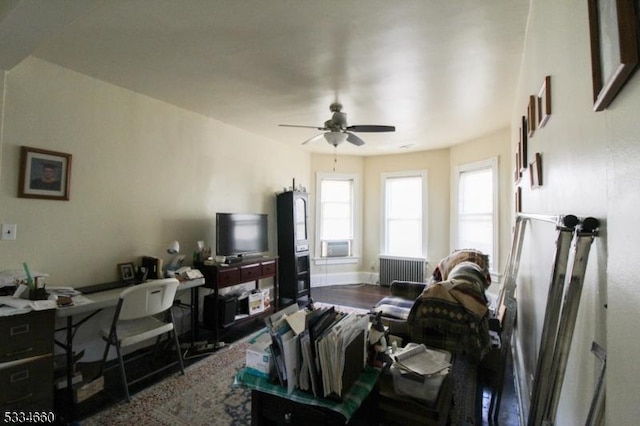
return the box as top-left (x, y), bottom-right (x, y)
top-left (276, 191), bottom-right (311, 306)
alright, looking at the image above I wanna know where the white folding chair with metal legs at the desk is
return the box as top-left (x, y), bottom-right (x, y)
top-left (102, 278), bottom-right (184, 402)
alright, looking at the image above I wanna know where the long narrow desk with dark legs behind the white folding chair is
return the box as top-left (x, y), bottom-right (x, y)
top-left (55, 278), bottom-right (205, 401)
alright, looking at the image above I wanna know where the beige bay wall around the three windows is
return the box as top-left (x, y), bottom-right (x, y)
top-left (311, 128), bottom-right (511, 285)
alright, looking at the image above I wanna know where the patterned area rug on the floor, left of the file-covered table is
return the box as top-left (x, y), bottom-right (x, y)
top-left (80, 341), bottom-right (251, 426)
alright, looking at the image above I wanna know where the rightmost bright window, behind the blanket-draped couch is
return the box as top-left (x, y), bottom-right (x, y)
top-left (451, 158), bottom-right (498, 271)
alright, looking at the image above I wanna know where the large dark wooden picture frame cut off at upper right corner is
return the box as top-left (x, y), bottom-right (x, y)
top-left (588, 0), bottom-right (638, 111)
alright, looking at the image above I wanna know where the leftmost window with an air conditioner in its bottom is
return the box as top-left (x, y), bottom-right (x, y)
top-left (316, 173), bottom-right (357, 258)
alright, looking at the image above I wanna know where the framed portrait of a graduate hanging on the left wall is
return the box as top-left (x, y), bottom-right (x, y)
top-left (18, 146), bottom-right (72, 201)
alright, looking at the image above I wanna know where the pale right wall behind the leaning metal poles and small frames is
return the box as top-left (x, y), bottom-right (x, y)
top-left (511, 0), bottom-right (640, 425)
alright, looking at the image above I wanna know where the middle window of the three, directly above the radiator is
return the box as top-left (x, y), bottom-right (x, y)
top-left (382, 171), bottom-right (427, 258)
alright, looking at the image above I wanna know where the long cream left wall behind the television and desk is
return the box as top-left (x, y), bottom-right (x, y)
top-left (0, 58), bottom-right (310, 360)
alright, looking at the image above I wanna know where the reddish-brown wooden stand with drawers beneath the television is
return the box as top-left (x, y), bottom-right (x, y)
top-left (194, 256), bottom-right (278, 344)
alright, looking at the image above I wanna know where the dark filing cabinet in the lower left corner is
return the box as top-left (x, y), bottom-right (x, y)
top-left (0, 309), bottom-right (55, 411)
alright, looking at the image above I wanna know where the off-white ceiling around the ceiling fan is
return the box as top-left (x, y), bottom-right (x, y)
top-left (0, 0), bottom-right (529, 155)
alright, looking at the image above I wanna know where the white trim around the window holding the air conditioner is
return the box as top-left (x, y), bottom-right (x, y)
top-left (313, 172), bottom-right (362, 265)
